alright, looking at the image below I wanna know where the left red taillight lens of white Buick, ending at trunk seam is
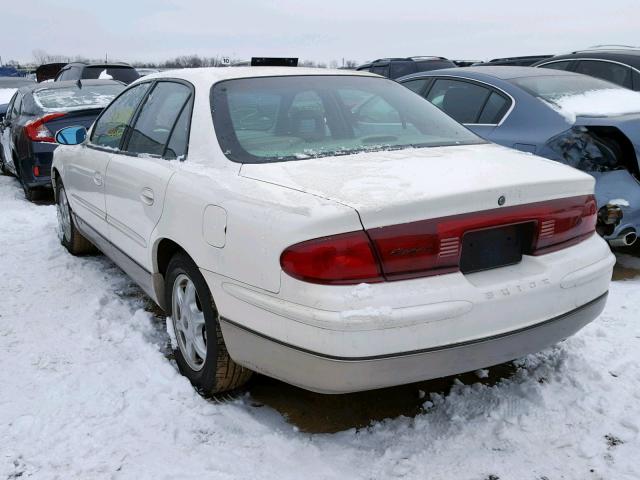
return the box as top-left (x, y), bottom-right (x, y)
top-left (280, 231), bottom-right (383, 285)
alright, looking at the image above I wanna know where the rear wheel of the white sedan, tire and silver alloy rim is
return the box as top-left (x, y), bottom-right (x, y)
top-left (165, 252), bottom-right (253, 395)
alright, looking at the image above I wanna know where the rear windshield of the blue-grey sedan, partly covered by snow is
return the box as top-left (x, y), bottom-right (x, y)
top-left (509, 75), bottom-right (622, 102)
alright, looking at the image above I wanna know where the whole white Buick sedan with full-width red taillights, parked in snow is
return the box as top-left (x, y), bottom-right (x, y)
top-left (52, 67), bottom-right (614, 393)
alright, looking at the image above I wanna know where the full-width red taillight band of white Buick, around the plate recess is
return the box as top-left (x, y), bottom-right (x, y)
top-left (280, 195), bottom-right (597, 285)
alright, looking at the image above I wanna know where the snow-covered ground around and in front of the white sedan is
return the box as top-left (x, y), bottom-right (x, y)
top-left (0, 173), bottom-right (640, 480)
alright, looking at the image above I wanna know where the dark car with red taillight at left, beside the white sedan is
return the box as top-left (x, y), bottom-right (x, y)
top-left (0, 80), bottom-right (125, 200)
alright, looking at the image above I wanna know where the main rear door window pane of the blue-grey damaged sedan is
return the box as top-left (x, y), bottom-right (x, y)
top-left (427, 79), bottom-right (491, 123)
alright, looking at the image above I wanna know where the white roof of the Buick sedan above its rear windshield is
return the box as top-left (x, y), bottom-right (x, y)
top-left (134, 67), bottom-right (381, 84)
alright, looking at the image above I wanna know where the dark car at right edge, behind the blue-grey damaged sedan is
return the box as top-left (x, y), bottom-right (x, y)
top-left (532, 45), bottom-right (640, 91)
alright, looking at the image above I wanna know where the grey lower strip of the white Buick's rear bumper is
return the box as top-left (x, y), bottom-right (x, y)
top-left (220, 293), bottom-right (607, 394)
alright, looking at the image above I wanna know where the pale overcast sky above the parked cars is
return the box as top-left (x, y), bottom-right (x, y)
top-left (0, 0), bottom-right (640, 62)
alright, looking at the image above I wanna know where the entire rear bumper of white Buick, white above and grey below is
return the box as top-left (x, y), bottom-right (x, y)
top-left (206, 235), bottom-right (615, 393)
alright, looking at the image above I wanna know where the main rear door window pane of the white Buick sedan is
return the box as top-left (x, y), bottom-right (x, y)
top-left (126, 82), bottom-right (191, 155)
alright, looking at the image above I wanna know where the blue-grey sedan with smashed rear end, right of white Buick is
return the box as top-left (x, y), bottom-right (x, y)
top-left (398, 66), bottom-right (640, 247)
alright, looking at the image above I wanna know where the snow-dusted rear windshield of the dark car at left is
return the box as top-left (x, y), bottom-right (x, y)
top-left (33, 82), bottom-right (125, 110)
